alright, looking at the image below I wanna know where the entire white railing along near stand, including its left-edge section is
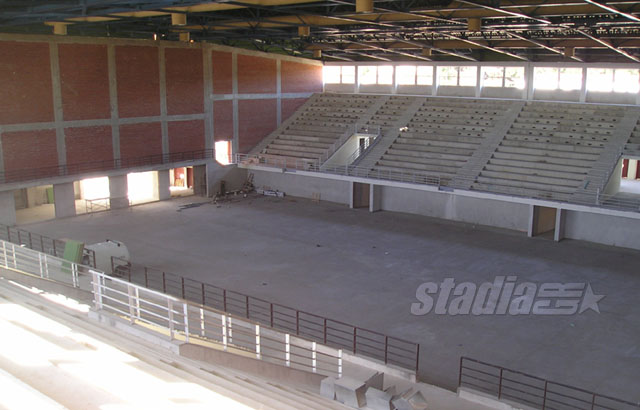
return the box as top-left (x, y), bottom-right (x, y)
top-left (0, 240), bottom-right (342, 377)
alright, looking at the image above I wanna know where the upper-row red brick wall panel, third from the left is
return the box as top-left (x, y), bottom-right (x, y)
top-left (116, 46), bottom-right (160, 118)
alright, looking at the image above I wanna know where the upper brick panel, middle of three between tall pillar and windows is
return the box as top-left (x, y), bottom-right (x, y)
top-left (238, 55), bottom-right (277, 94)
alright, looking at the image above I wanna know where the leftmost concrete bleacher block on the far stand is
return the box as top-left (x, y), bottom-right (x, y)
top-left (262, 94), bottom-right (380, 161)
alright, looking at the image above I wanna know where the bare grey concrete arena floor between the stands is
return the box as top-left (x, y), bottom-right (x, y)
top-left (18, 197), bottom-right (640, 401)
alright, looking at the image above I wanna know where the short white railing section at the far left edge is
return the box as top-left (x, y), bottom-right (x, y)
top-left (0, 240), bottom-right (92, 288)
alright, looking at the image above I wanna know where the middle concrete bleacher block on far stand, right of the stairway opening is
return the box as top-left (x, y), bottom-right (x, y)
top-left (374, 98), bottom-right (509, 185)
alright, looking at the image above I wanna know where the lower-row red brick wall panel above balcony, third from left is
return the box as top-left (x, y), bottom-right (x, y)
top-left (120, 122), bottom-right (162, 158)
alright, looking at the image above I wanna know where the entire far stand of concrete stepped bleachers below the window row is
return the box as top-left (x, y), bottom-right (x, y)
top-left (248, 93), bottom-right (640, 207)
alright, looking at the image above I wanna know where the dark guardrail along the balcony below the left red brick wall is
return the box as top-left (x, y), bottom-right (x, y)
top-left (0, 149), bottom-right (214, 184)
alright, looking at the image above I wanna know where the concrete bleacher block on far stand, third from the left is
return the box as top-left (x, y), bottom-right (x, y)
top-left (472, 102), bottom-right (624, 201)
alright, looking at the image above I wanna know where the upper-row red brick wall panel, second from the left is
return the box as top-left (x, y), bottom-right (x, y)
top-left (58, 44), bottom-right (111, 121)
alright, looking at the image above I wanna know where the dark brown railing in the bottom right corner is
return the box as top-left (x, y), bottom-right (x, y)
top-left (458, 356), bottom-right (640, 410)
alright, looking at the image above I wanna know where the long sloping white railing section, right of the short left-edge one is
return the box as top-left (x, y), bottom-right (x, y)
top-left (91, 271), bottom-right (342, 377)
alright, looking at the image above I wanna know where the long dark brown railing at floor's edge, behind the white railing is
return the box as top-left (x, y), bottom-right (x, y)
top-left (111, 257), bottom-right (420, 372)
